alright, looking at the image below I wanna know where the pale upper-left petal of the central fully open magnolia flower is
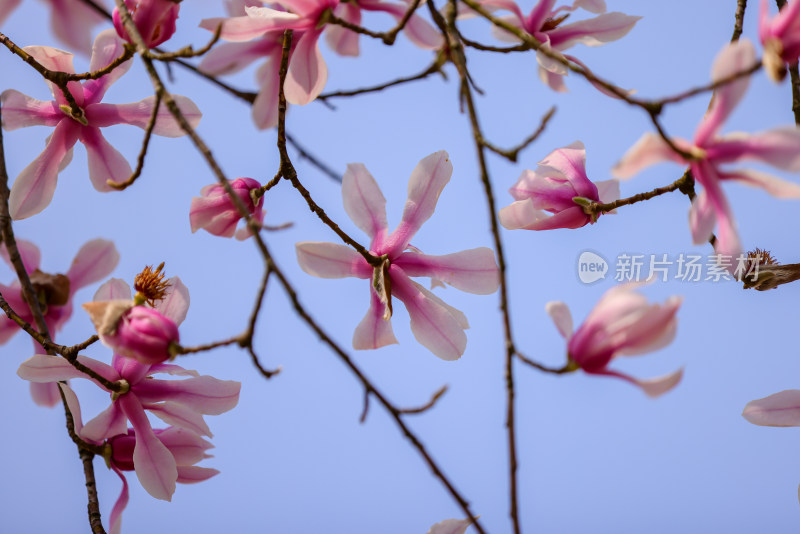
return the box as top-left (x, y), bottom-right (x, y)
top-left (342, 163), bottom-right (388, 241)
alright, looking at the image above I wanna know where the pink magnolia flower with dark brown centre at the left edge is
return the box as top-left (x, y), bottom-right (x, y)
top-left (0, 239), bottom-right (119, 406)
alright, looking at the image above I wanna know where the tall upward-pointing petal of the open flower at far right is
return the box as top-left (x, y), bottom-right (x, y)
top-left (694, 39), bottom-right (756, 146)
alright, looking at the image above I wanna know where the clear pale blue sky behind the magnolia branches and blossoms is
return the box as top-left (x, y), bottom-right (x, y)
top-left (0, 0), bottom-right (800, 534)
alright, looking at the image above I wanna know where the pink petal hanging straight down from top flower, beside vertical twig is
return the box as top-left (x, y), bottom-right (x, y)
top-left (283, 29), bottom-right (328, 106)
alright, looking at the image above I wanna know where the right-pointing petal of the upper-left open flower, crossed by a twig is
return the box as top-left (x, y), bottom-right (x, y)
top-left (86, 95), bottom-right (203, 137)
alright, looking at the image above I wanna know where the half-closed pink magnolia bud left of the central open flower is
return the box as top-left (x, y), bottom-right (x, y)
top-left (189, 178), bottom-right (264, 239)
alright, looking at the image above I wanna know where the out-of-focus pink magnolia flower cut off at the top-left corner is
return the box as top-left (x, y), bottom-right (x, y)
top-left (0, 0), bottom-right (105, 55)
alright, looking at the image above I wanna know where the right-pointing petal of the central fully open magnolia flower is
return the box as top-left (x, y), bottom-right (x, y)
top-left (395, 247), bottom-right (500, 295)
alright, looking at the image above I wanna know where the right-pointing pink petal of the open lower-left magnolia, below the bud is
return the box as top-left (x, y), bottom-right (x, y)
top-left (136, 375), bottom-right (242, 415)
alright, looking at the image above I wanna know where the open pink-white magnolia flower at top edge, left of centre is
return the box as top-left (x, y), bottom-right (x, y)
top-left (200, 0), bottom-right (339, 109)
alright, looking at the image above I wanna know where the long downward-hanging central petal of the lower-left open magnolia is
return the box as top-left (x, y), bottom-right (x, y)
top-left (117, 393), bottom-right (178, 501)
